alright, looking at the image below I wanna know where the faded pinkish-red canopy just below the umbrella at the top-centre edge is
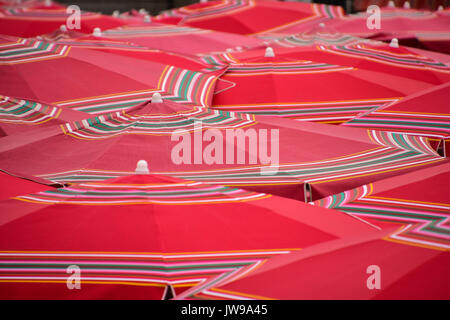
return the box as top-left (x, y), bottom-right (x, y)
top-left (81, 23), bottom-right (264, 55)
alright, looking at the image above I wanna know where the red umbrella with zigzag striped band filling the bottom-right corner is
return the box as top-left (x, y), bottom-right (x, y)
top-left (192, 162), bottom-right (450, 299)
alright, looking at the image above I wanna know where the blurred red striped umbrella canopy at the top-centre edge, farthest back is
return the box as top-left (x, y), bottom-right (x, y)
top-left (156, 0), bottom-right (343, 35)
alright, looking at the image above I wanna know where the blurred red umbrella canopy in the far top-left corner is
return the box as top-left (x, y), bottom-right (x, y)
top-left (0, 7), bottom-right (127, 37)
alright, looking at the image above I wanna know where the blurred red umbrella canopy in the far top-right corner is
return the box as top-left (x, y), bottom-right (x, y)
top-left (322, 7), bottom-right (450, 54)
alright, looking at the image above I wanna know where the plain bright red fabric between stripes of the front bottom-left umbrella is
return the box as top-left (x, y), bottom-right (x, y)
top-left (0, 175), bottom-right (376, 299)
